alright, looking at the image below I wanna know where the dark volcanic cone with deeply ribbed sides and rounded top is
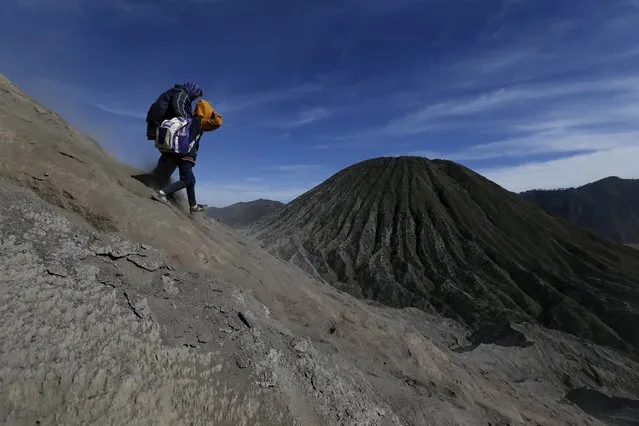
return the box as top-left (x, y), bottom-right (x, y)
top-left (249, 157), bottom-right (639, 351)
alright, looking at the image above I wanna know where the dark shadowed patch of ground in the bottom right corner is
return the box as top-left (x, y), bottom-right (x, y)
top-left (566, 388), bottom-right (639, 426)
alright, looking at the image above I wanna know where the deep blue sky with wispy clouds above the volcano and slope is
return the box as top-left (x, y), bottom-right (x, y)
top-left (0, 0), bottom-right (639, 206)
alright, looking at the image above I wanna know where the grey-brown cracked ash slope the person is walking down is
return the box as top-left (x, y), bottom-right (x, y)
top-left (0, 75), bottom-right (639, 426)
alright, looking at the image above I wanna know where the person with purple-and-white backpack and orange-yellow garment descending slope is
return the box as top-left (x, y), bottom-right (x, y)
top-left (153, 99), bottom-right (222, 213)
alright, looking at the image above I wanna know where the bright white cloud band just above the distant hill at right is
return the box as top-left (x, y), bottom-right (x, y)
top-left (477, 146), bottom-right (639, 192)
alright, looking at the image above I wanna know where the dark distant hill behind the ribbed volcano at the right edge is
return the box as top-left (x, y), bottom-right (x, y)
top-left (520, 177), bottom-right (639, 244)
